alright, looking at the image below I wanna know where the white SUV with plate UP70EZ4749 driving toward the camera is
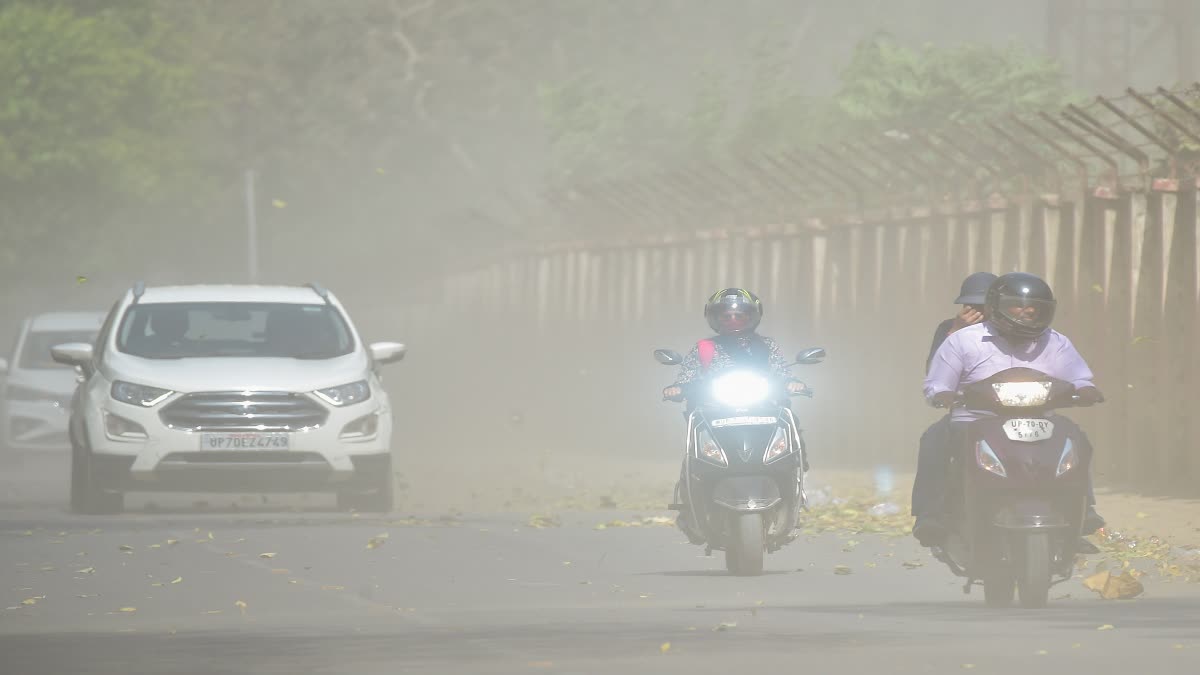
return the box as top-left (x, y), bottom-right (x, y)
top-left (52, 282), bottom-right (404, 513)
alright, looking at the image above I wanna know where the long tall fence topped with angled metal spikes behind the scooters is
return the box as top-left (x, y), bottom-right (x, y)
top-left (403, 86), bottom-right (1200, 494)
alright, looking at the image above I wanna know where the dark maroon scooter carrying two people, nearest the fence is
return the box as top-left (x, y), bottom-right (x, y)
top-left (931, 368), bottom-right (1094, 608)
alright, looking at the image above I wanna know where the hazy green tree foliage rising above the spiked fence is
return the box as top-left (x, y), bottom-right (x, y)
top-left (542, 35), bottom-right (1068, 183)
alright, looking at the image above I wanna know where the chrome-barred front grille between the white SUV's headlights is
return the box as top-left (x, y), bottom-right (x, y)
top-left (160, 392), bottom-right (329, 431)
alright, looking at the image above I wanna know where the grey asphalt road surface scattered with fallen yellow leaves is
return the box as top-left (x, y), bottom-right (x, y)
top-left (0, 454), bottom-right (1200, 675)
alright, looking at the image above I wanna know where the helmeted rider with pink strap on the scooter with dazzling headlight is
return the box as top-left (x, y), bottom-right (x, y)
top-left (662, 288), bottom-right (808, 544)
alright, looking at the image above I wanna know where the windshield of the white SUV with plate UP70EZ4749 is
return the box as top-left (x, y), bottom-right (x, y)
top-left (116, 303), bottom-right (354, 359)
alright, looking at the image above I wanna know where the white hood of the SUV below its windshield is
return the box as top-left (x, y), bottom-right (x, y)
top-left (104, 353), bottom-right (367, 393)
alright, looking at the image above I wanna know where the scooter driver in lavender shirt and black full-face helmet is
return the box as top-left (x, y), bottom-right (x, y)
top-left (913, 273), bottom-right (1104, 546)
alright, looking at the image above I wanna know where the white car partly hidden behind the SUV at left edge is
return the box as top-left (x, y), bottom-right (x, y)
top-left (0, 312), bottom-right (104, 456)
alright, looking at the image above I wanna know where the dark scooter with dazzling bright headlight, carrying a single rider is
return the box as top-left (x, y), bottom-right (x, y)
top-left (654, 348), bottom-right (826, 575)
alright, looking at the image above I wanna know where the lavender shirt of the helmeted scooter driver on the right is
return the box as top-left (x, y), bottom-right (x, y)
top-left (925, 322), bottom-right (1096, 422)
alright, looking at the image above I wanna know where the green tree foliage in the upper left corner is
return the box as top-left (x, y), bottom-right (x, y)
top-left (0, 2), bottom-right (199, 261)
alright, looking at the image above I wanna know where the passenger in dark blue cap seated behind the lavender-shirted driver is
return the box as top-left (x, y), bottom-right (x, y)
top-left (912, 271), bottom-right (996, 532)
